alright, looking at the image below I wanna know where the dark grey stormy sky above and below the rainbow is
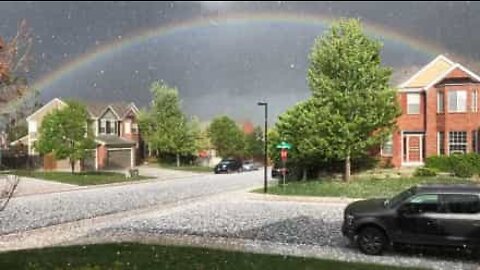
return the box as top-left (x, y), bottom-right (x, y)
top-left (0, 2), bottom-right (480, 123)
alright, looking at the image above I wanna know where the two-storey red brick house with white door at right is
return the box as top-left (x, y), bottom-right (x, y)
top-left (380, 55), bottom-right (480, 168)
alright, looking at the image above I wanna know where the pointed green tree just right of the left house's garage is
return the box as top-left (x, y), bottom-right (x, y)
top-left (139, 81), bottom-right (198, 167)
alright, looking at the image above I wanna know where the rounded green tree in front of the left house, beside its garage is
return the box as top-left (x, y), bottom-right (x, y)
top-left (35, 101), bottom-right (95, 174)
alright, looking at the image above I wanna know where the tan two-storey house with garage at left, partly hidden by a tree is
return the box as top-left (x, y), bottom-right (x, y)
top-left (24, 98), bottom-right (143, 170)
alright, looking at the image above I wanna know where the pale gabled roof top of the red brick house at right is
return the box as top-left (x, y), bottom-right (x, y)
top-left (399, 55), bottom-right (480, 90)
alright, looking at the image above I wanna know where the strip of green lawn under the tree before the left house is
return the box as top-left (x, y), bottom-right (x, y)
top-left (12, 171), bottom-right (149, 186)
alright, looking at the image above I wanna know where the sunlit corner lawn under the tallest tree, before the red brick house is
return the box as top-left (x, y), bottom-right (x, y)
top-left (255, 177), bottom-right (471, 198)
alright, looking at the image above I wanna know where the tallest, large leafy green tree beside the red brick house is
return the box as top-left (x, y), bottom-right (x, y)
top-left (306, 19), bottom-right (400, 181)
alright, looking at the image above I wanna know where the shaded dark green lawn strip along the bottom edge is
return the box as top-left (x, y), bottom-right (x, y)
top-left (0, 243), bottom-right (422, 270)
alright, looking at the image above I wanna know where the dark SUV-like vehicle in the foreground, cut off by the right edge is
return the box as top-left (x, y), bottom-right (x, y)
top-left (342, 185), bottom-right (480, 255)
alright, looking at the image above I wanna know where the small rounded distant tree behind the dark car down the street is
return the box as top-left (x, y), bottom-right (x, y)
top-left (208, 116), bottom-right (245, 157)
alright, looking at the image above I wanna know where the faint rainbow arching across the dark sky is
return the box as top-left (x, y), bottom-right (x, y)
top-left (2, 12), bottom-right (462, 112)
